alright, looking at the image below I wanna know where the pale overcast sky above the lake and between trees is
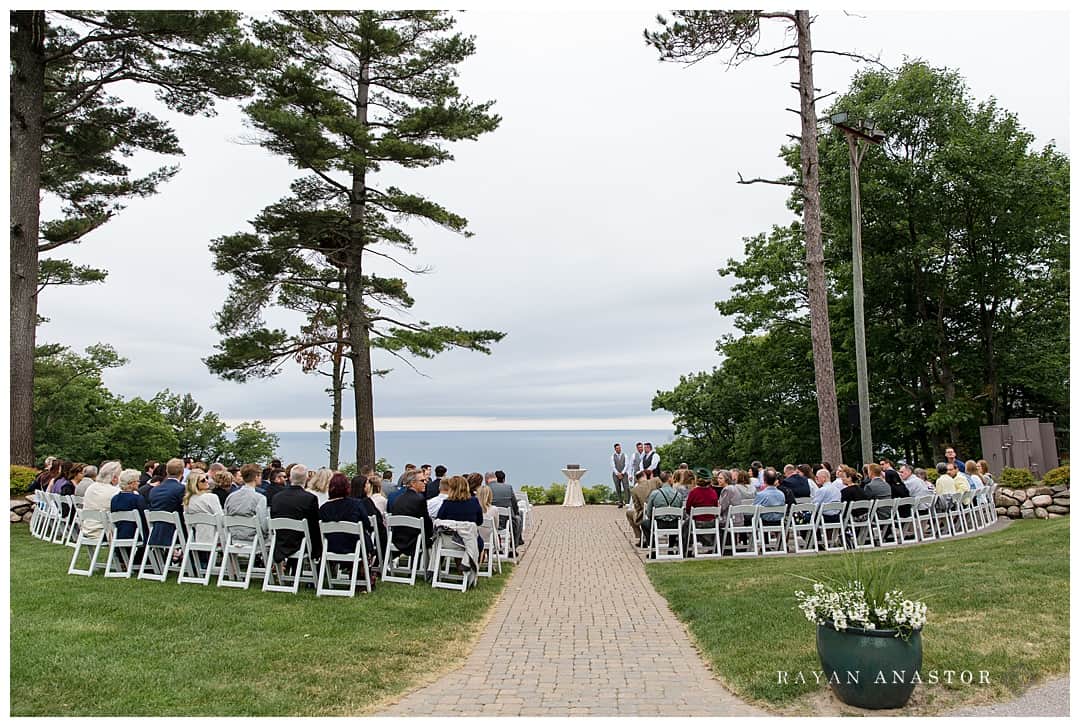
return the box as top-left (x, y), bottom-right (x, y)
top-left (38, 10), bottom-right (1069, 431)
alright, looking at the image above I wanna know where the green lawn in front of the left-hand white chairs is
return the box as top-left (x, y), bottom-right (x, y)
top-left (10, 525), bottom-right (509, 716)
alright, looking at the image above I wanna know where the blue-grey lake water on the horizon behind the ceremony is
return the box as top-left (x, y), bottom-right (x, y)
top-left (275, 430), bottom-right (672, 487)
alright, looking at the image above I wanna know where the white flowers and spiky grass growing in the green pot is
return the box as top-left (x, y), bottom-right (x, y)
top-left (795, 557), bottom-right (927, 641)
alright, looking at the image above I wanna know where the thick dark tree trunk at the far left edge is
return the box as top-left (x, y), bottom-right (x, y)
top-left (9, 10), bottom-right (45, 466)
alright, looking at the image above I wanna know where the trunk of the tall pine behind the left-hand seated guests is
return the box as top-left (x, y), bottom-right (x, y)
top-left (345, 55), bottom-right (375, 471)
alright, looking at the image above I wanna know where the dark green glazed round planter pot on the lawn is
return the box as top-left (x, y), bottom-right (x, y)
top-left (818, 622), bottom-right (922, 710)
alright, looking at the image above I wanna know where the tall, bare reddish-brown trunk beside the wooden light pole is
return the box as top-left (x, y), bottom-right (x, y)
top-left (795, 10), bottom-right (843, 462)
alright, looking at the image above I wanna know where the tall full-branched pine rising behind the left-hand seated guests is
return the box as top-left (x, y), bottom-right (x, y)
top-left (216, 11), bottom-right (504, 467)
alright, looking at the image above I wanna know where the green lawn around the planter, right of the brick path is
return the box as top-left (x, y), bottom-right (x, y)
top-left (646, 517), bottom-right (1069, 713)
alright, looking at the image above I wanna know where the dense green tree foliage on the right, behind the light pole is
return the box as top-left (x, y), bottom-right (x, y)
top-left (650, 59), bottom-right (1069, 463)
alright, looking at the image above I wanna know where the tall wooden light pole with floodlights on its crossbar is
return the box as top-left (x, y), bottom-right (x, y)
top-left (829, 113), bottom-right (885, 465)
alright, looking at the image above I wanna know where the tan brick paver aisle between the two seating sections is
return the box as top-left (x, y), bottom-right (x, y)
top-left (382, 506), bottom-right (764, 716)
